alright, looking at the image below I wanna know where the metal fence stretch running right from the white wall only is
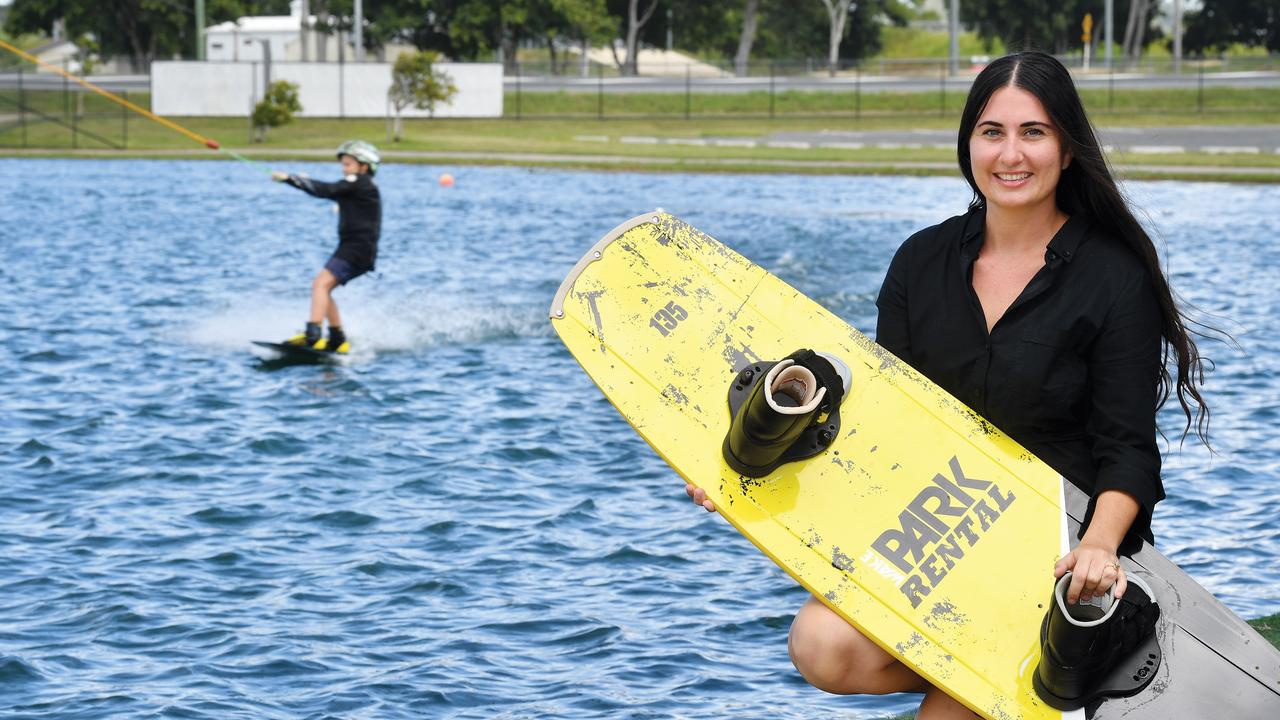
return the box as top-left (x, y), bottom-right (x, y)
top-left (506, 55), bottom-right (1280, 119)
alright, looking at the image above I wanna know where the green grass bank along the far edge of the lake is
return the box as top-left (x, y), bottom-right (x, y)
top-left (0, 88), bottom-right (1280, 182)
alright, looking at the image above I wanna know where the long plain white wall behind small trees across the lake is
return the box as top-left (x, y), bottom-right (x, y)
top-left (151, 61), bottom-right (503, 118)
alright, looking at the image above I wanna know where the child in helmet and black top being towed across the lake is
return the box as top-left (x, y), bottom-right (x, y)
top-left (271, 140), bottom-right (383, 352)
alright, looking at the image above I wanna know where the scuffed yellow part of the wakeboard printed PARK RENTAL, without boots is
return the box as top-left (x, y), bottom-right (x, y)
top-left (550, 211), bottom-right (1280, 720)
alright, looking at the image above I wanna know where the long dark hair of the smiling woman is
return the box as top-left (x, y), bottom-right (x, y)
top-left (956, 53), bottom-right (1212, 446)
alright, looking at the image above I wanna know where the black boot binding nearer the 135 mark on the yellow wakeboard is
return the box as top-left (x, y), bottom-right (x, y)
top-left (722, 350), bottom-right (850, 478)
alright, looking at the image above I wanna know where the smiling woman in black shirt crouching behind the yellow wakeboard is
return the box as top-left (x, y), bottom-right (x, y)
top-left (686, 53), bottom-right (1208, 720)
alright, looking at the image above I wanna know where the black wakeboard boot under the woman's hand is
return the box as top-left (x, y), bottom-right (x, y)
top-left (1032, 573), bottom-right (1161, 710)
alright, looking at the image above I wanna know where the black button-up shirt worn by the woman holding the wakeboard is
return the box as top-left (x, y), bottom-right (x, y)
top-left (876, 209), bottom-right (1165, 544)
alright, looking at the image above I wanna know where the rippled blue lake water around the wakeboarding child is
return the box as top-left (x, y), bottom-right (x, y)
top-left (0, 160), bottom-right (1280, 720)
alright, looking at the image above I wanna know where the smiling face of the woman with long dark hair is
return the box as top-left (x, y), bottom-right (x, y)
top-left (969, 86), bottom-right (1071, 210)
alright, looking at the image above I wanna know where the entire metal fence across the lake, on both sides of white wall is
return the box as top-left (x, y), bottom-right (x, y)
top-left (0, 55), bottom-right (1280, 149)
